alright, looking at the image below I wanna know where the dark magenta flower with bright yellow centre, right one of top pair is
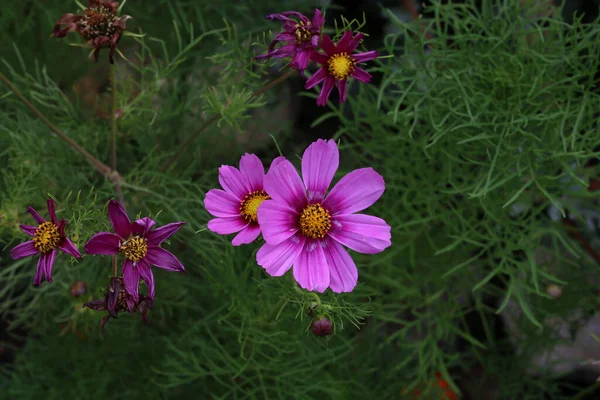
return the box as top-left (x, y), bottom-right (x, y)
top-left (304, 31), bottom-right (377, 106)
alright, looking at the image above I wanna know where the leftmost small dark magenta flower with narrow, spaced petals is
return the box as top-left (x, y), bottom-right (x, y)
top-left (10, 199), bottom-right (81, 286)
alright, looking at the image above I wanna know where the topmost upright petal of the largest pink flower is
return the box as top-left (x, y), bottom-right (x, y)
top-left (302, 139), bottom-right (340, 203)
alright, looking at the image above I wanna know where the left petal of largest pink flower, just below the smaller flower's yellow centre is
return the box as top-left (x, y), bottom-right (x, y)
top-left (258, 200), bottom-right (299, 245)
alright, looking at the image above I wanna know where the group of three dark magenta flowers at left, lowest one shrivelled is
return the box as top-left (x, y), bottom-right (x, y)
top-left (11, 199), bottom-right (185, 333)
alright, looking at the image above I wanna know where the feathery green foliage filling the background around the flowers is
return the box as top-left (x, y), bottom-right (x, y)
top-left (0, 0), bottom-right (600, 400)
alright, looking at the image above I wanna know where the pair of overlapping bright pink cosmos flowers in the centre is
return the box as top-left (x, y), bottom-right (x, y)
top-left (204, 139), bottom-right (391, 293)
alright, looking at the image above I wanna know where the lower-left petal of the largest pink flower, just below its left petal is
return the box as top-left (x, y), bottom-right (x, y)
top-left (256, 234), bottom-right (306, 276)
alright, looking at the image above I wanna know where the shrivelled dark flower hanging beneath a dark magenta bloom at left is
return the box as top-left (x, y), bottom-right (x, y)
top-left (83, 276), bottom-right (152, 336)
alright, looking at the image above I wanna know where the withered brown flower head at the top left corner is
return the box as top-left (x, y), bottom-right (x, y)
top-left (54, 0), bottom-right (131, 64)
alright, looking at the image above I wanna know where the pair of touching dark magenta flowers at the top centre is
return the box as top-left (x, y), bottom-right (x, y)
top-left (255, 9), bottom-right (377, 106)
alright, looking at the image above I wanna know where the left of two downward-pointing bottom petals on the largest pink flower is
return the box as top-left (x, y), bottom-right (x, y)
top-left (294, 240), bottom-right (329, 293)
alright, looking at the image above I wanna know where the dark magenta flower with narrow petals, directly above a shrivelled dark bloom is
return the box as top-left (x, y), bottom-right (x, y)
top-left (85, 200), bottom-right (185, 302)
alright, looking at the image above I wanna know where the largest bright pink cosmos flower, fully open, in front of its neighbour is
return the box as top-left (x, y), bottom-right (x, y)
top-left (256, 139), bottom-right (392, 293)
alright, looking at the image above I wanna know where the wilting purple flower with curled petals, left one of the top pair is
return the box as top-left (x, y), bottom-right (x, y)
top-left (255, 9), bottom-right (325, 72)
